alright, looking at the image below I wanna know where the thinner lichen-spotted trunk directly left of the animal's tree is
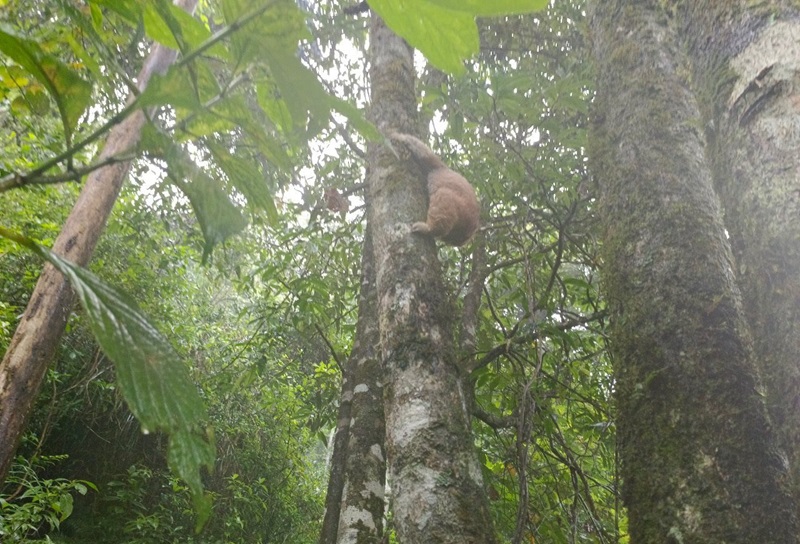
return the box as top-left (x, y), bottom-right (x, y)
top-left (320, 223), bottom-right (386, 544)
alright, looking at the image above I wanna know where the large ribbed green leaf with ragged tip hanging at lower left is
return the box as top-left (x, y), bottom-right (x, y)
top-left (0, 227), bottom-right (215, 523)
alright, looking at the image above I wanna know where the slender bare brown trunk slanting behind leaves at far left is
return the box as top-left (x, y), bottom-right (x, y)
top-left (0, 0), bottom-right (197, 484)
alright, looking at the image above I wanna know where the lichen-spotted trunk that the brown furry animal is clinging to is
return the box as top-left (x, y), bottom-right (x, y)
top-left (367, 15), bottom-right (496, 544)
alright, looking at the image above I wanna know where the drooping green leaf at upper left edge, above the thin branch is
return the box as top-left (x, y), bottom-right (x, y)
top-left (0, 25), bottom-right (92, 143)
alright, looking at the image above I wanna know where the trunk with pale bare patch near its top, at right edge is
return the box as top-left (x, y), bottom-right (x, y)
top-left (683, 1), bottom-right (800, 498)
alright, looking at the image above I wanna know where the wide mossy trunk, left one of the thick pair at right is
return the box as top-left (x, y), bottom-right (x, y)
top-left (591, 0), bottom-right (797, 544)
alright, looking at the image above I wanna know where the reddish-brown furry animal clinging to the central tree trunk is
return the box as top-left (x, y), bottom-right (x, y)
top-left (389, 132), bottom-right (480, 246)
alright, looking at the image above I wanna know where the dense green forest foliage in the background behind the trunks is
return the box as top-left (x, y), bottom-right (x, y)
top-left (0, 0), bottom-right (625, 543)
